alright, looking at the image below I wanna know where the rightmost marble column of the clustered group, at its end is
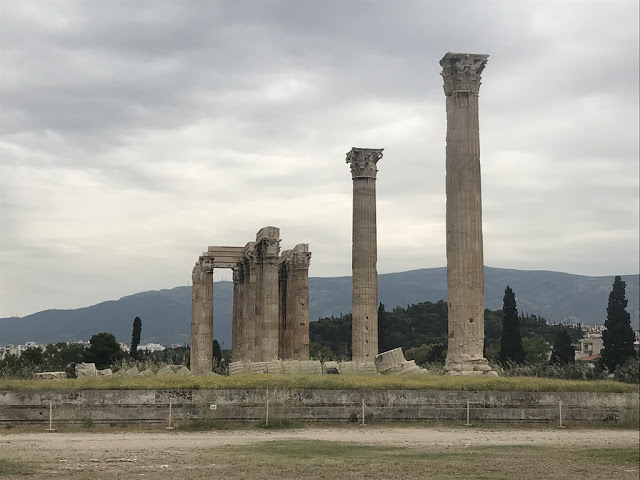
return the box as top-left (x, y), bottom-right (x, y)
top-left (286, 243), bottom-right (311, 360)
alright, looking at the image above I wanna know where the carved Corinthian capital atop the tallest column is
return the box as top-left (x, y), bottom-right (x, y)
top-left (440, 52), bottom-right (489, 97)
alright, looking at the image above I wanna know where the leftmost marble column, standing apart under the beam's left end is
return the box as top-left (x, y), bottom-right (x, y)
top-left (190, 256), bottom-right (213, 375)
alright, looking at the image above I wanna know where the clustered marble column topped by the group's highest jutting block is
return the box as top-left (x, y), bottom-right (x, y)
top-left (256, 227), bottom-right (280, 362)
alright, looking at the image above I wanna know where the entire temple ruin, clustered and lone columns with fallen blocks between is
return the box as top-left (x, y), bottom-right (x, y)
top-left (191, 53), bottom-right (496, 375)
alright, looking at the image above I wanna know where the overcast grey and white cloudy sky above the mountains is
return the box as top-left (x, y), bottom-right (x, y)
top-left (0, 0), bottom-right (639, 317)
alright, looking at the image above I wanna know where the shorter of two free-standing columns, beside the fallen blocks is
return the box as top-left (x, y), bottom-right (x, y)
top-left (347, 147), bottom-right (384, 362)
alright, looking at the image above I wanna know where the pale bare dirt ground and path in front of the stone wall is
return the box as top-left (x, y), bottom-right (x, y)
top-left (0, 427), bottom-right (639, 479)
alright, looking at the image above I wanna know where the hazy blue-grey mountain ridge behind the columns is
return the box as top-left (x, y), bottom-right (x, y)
top-left (0, 267), bottom-right (640, 347)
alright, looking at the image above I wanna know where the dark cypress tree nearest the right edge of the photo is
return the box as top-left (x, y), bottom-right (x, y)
top-left (602, 275), bottom-right (634, 373)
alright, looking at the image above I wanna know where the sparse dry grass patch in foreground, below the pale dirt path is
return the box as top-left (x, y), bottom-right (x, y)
top-left (204, 440), bottom-right (638, 480)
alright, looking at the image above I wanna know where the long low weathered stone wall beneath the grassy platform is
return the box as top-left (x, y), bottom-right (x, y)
top-left (0, 389), bottom-right (638, 428)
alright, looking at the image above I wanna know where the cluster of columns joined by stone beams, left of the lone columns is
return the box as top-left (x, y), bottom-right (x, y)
top-left (191, 227), bottom-right (311, 375)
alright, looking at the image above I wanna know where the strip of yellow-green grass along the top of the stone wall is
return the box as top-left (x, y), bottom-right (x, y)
top-left (0, 375), bottom-right (638, 393)
